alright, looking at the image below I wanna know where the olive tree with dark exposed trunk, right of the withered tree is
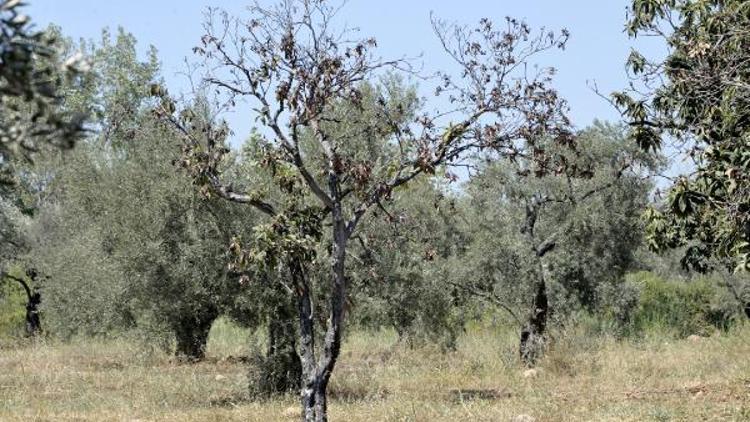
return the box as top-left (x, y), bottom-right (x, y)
top-left (453, 123), bottom-right (658, 365)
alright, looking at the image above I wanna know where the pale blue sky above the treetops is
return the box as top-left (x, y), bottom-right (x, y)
top-left (26, 0), bottom-right (661, 148)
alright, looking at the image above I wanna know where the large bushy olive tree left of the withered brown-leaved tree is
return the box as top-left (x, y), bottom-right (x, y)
top-left (25, 30), bottom-right (268, 360)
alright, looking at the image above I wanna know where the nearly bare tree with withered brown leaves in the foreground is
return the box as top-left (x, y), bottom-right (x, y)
top-left (153, 0), bottom-right (573, 421)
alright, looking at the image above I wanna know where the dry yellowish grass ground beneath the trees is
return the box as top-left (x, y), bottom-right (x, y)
top-left (0, 323), bottom-right (750, 422)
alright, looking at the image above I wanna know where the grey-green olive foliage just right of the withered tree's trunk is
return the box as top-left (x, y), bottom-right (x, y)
top-left (350, 178), bottom-right (469, 349)
